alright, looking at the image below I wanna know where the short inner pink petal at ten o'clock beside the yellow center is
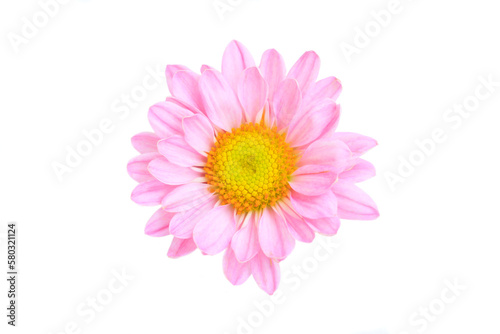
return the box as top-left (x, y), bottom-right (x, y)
top-left (182, 114), bottom-right (215, 156)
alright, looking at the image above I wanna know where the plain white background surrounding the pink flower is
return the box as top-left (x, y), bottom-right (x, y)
top-left (0, 0), bottom-right (500, 334)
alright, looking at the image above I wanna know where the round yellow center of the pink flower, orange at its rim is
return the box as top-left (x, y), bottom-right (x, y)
top-left (204, 123), bottom-right (297, 214)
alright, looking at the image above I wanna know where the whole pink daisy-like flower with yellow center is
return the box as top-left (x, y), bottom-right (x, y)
top-left (128, 41), bottom-right (378, 294)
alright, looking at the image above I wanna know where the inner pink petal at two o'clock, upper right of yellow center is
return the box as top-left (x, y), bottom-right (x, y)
top-left (286, 100), bottom-right (339, 147)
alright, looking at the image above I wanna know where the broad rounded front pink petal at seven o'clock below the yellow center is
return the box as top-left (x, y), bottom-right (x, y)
top-left (193, 205), bottom-right (236, 255)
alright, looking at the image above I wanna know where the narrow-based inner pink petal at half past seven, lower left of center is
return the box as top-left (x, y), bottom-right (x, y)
top-left (170, 196), bottom-right (217, 239)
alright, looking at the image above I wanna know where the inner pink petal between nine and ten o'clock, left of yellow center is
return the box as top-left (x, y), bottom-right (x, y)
top-left (158, 135), bottom-right (203, 167)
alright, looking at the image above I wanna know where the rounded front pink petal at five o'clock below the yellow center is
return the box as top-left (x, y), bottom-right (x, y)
top-left (259, 208), bottom-right (295, 259)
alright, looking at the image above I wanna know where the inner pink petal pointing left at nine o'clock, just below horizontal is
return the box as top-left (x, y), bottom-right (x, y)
top-left (148, 157), bottom-right (203, 185)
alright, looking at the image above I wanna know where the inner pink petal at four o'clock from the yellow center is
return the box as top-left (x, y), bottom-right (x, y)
top-left (290, 190), bottom-right (337, 219)
